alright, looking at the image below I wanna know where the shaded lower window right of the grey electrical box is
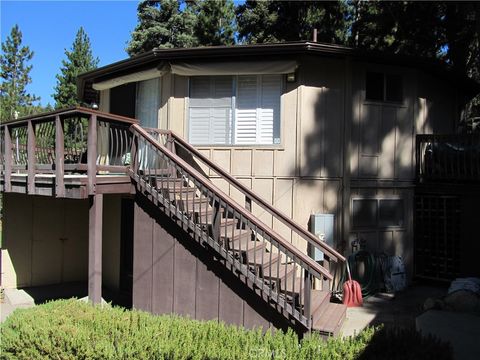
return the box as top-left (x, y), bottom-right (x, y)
top-left (352, 199), bottom-right (404, 228)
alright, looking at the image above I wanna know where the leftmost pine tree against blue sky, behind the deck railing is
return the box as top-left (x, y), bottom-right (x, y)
top-left (0, 25), bottom-right (40, 121)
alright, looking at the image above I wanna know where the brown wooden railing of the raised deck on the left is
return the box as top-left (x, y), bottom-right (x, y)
top-left (0, 107), bottom-right (136, 197)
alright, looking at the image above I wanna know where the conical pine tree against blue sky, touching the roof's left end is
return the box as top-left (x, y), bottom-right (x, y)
top-left (53, 27), bottom-right (99, 109)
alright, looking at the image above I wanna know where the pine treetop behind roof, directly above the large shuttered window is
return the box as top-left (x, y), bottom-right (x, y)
top-left (195, 0), bottom-right (235, 46)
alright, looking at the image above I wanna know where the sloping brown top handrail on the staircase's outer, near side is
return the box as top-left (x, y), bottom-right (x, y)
top-left (131, 124), bottom-right (333, 280)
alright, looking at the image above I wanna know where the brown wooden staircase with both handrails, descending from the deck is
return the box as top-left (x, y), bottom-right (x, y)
top-left (130, 125), bottom-right (346, 336)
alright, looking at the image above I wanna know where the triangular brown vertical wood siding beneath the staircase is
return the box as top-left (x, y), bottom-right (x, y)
top-left (133, 195), bottom-right (294, 329)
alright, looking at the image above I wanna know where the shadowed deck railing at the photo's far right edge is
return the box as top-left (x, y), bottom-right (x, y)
top-left (415, 134), bottom-right (480, 183)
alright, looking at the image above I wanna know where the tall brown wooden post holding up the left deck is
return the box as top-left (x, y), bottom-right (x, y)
top-left (88, 194), bottom-right (103, 304)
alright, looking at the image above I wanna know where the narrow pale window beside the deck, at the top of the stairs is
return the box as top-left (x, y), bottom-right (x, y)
top-left (135, 78), bottom-right (160, 128)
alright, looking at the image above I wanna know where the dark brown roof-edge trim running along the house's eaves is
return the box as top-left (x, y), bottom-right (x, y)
top-left (77, 41), bottom-right (480, 99)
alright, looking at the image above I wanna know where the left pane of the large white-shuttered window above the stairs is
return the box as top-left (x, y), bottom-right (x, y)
top-left (189, 76), bottom-right (232, 145)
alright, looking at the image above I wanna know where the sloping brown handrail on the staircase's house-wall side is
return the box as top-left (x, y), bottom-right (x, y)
top-left (152, 130), bottom-right (345, 262)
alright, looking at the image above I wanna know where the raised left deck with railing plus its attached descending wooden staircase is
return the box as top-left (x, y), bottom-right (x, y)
top-left (0, 108), bottom-right (346, 335)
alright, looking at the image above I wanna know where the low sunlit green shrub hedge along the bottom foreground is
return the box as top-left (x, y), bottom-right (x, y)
top-left (0, 300), bottom-right (451, 360)
